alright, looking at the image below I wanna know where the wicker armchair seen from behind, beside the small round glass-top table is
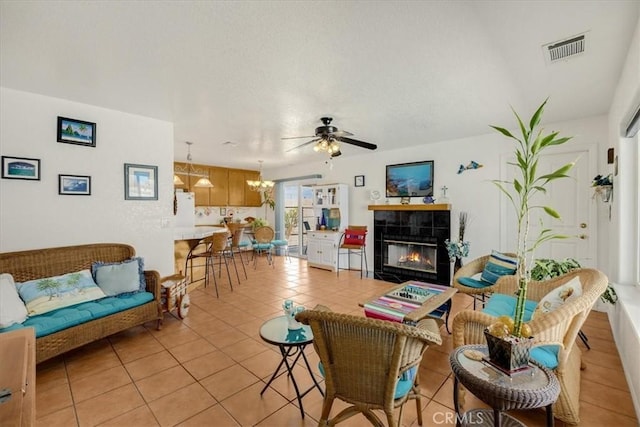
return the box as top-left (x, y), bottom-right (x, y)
top-left (296, 307), bottom-right (442, 427)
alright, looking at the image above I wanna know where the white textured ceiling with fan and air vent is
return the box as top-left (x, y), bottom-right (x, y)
top-left (0, 0), bottom-right (640, 169)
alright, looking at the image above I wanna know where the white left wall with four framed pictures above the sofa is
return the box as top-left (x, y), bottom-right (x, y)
top-left (0, 88), bottom-right (174, 275)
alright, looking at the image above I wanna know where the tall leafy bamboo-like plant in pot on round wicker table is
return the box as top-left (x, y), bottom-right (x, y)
top-left (485, 100), bottom-right (574, 370)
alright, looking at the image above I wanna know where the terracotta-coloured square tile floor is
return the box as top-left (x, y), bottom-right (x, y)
top-left (36, 257), bottom-right (638, 427)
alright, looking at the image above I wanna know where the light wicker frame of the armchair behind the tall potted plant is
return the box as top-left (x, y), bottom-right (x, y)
top-left (453, 268), bottom-right (608, 424)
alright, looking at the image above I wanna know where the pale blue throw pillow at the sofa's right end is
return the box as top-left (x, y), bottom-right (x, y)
top-left (91, 257), bottom-right (147, 296)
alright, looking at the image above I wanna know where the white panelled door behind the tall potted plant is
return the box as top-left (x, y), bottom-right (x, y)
top-left (502, 148), bottom-right (597, 267)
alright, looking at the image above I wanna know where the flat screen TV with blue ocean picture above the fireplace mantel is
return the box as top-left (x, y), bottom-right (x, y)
top-left (387, 160), bottom-right (433, 197)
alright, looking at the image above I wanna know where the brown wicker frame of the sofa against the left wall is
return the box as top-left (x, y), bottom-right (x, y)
top-left (0, 243), bottom-right (162, 363)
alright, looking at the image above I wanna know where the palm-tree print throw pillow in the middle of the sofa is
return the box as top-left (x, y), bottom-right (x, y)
top-left (16, 270), bottom-right (106, 315)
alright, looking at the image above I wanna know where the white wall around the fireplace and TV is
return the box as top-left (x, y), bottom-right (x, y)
top-left (264, 113), bottom-right (607, 270)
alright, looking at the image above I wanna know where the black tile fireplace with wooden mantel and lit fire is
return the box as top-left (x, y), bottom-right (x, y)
top-left (369, 204), bottom-right (451, 286)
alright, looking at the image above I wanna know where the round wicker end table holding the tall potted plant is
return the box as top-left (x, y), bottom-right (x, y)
top-left (449, 345), bottom-right (560, 427)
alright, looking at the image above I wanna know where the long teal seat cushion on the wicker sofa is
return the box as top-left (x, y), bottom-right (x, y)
top-left (0, 292), bottom-right (153, 338)
